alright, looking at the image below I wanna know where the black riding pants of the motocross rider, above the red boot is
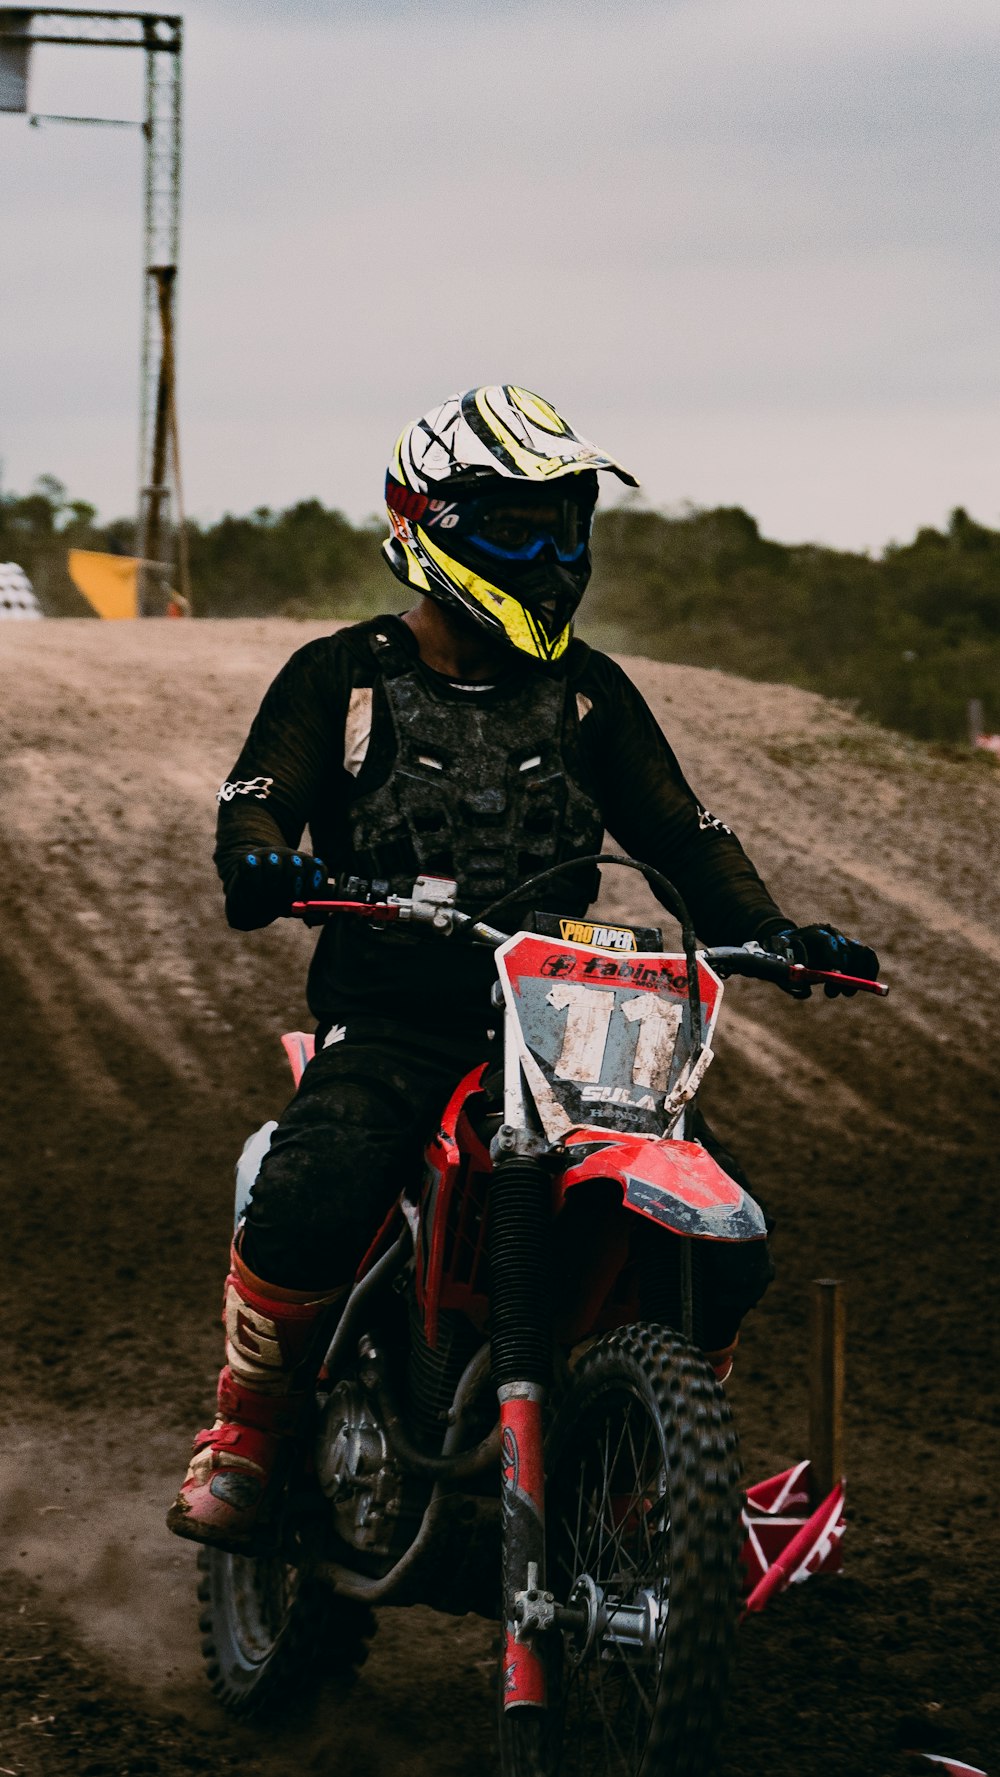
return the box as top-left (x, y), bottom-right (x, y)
top-left (242, 1018), bottom-right (771, 1345)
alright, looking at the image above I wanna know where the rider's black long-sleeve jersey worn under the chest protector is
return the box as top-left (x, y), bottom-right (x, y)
top-left (215, 617), bottom-right (787, 1029)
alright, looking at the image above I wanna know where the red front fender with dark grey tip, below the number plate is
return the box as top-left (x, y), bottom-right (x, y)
top-left (560, 1128), bottom-right (767, 1240)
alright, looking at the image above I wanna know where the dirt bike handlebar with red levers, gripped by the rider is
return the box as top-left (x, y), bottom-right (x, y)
top-left (291, 889), bottom-right (888, 999)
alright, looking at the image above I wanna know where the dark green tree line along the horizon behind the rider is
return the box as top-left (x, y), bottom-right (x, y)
top-left (0, 476), bottom-right (1000, 741)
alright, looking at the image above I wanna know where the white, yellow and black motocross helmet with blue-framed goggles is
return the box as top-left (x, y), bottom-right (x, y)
top-left (384, 382), bottom-right (638, 661)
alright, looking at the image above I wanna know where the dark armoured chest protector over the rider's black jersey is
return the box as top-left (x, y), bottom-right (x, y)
top-left (348, 636), bottom-right (604, 913)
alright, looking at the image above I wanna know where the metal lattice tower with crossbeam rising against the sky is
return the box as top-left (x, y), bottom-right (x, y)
top-left (0, 7), bottom-right (190, 613)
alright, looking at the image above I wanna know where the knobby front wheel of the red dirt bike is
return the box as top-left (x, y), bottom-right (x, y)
top-left (501, 1326), bottom-right (741, 1777)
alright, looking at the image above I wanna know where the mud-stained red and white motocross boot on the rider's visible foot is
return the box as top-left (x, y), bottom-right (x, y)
top-left (167, 1244), bottom-right (345, 1555)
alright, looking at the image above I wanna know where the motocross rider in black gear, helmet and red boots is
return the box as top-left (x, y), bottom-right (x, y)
top-left (167, 384), bottom-right (877, 1553)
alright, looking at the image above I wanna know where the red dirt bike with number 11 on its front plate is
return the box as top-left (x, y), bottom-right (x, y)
top-left (199, 858), bottom-right (886, 1777)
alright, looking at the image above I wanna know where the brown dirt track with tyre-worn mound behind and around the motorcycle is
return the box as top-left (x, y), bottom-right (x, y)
top-left (0, 622), bottom-right (1000, 1777)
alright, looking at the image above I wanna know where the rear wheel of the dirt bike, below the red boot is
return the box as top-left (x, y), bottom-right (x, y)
top-left (197, 1548), bottom-right (375, 1718)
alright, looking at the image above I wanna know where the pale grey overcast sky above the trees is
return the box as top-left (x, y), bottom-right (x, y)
top-left (0, 0), bottom-right (1000, 549)
